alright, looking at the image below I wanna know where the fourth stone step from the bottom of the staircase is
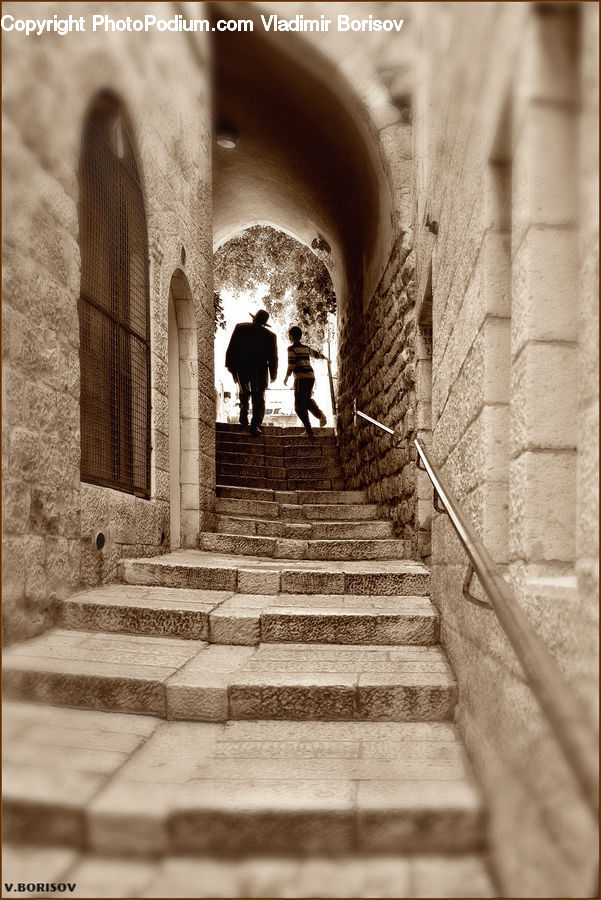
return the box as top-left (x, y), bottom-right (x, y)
top-left (59, 584), bottom-right (439, 645)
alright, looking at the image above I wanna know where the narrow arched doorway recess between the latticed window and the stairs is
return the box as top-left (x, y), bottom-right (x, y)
top-left (168, 269), bottom-right (199, 549)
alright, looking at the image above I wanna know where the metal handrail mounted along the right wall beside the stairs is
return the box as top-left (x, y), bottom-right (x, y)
top-left (354, 409), bottom-right (599, 819)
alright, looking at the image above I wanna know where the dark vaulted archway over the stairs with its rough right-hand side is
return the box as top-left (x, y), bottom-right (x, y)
top-left (213, 3), bottom-right (419, 554)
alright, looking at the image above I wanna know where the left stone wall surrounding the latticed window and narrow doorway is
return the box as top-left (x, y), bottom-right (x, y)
top-left (3, 3), bottom-right (215, 640)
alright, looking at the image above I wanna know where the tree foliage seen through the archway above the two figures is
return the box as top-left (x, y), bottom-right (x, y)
top-left (214, 225), bottom-right (336, 348)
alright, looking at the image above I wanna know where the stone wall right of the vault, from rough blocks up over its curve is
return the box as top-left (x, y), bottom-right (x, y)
top-left (302, 3), bottom-right (424, 557)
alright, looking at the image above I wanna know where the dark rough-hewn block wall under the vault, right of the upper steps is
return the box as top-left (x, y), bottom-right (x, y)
top-left (338, 225), bottom-right (422, 556)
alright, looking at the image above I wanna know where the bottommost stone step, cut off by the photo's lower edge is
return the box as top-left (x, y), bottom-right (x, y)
top-left (2, 843), bottom-right (498, 898)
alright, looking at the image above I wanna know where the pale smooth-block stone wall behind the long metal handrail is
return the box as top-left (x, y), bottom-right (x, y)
top-left (414, 3), bottom-right (597, 896)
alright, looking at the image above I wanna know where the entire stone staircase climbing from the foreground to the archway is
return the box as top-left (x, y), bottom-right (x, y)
top-left (3, 426), bottom-right (494, 897)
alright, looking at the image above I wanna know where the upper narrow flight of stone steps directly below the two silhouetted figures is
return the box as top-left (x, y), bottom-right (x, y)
top-left (209, 424), bottom-right (411, 561)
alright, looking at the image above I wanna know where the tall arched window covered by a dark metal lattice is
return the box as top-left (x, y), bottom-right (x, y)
top-left (79, 96), bottom-right (150, 497)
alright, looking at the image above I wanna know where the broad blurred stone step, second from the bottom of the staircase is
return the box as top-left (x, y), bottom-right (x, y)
top-left (3, 702), bottom-right (486, 864)
